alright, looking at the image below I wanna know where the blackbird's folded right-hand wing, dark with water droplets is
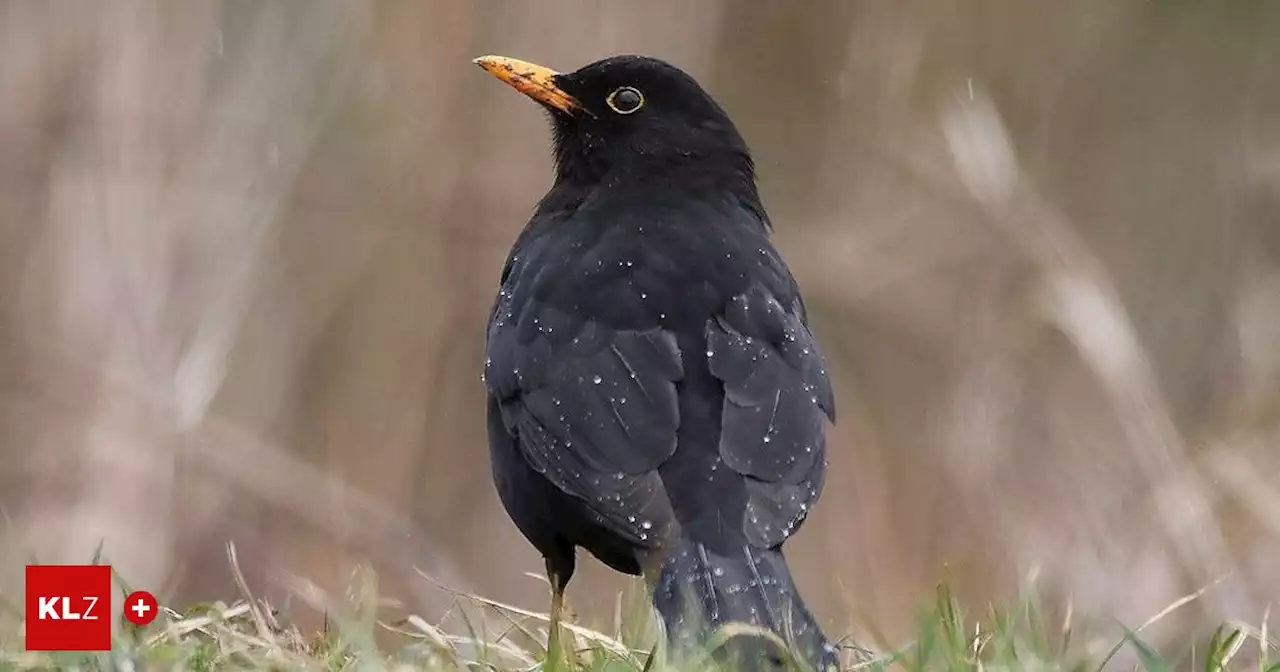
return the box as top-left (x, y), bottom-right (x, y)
top-left (707, 280), bottom-right (835, 547)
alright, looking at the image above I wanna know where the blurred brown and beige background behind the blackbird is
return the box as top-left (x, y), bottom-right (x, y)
top-left (0, 0), bottom-right (1280, 650)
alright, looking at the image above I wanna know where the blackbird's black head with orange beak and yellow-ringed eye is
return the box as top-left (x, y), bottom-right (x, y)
top-left (475, 51), bottom-right (754, 188)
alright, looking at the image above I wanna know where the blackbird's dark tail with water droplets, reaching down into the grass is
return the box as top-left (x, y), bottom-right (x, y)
top-left (653, 539), bottom-right (836, 671)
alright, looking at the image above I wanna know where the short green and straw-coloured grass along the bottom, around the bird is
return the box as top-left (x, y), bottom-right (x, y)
top-left (0, 549), bottom-right (1280, 672)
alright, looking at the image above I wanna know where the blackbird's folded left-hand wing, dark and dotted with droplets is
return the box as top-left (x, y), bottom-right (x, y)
top-left (485, 301), bottom-right (682, 545)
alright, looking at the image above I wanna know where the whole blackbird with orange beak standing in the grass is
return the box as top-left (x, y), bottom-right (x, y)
top-left (476, 56), bottom-right (835, 669)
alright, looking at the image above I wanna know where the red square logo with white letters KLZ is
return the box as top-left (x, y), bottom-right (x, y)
top-left (27, 564), bottom-right (111, 652)
